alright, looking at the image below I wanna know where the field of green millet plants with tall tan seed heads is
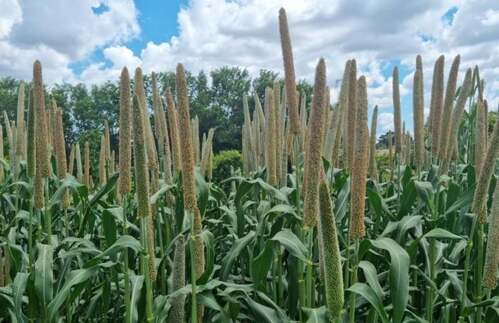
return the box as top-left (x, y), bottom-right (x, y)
top-left (0, 9), bottom-right (499, 323)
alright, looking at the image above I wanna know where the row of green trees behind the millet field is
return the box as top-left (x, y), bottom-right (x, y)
top-left (0, 66), bottom-right (312, 152)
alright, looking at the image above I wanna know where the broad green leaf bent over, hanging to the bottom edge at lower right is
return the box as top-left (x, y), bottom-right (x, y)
top-left (371, 238), bottom-right (410, 323)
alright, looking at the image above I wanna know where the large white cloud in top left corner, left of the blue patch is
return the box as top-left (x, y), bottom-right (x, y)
top-left (0, 0), bottom-right (140, 83)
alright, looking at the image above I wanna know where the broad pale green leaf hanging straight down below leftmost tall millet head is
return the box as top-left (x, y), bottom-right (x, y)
top-left (35, 243), bottom-right (54, 307)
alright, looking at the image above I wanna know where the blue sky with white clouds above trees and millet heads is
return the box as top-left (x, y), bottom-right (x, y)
top-left (0, 0), bottom-right (499, 133)
